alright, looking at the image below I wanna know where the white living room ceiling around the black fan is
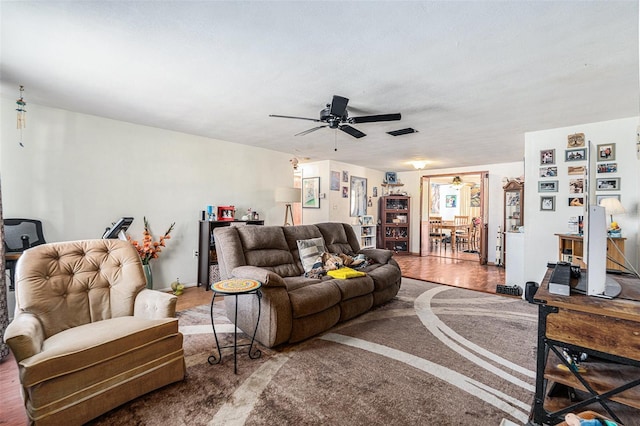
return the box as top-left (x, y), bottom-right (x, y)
top-left (0, 0), bottom-right (639, 171)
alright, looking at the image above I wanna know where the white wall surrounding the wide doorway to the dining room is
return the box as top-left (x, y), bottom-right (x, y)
top-left (398, 161), bottom-right (532, 263)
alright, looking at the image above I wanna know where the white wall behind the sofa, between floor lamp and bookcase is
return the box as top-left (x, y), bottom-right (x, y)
top-left (300, 160), bottom-right (384, 224)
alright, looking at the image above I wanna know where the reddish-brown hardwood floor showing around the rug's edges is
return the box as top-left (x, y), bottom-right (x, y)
top-left (0, 256), bottom-right (504, 426)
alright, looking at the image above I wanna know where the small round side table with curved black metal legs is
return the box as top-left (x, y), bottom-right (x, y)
top-left (207, 278), bottom-right (262, 374)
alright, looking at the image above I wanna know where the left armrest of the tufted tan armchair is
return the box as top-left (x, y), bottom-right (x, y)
top-left (4, 312), bottom-right (44, 362)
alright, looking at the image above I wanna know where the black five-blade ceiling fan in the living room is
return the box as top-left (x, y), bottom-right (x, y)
top-left (269, 95), bottom-right (401, 139)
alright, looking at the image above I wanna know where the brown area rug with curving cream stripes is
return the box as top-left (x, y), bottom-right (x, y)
top-left (91, 278), bottom-right (537, 426)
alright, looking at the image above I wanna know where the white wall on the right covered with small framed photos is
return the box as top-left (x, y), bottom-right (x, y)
top-left (524, 117), bottom-right (640, 282)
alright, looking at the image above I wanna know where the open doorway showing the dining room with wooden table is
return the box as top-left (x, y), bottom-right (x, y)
top-left (420, 171), bottom-right (489, 265)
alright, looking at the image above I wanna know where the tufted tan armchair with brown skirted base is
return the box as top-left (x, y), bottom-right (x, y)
top-left (5, 240), bottom-right (185, 425)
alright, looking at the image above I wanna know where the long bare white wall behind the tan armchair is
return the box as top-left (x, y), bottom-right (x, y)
top-left (0, 98), bottom-right (293, 289)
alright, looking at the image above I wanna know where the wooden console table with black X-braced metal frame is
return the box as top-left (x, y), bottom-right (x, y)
top-left (530, 270), bottom-right (640, 425)
